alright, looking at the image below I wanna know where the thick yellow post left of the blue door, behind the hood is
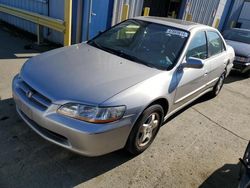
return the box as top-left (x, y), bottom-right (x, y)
top-left (64, 0), bottom-right (72, 46)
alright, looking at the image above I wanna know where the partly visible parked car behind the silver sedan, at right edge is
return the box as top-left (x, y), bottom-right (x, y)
top-left (223, 28), bottom-right (250, 77)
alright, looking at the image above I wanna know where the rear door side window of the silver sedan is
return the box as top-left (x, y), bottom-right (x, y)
top-left (207, 31), bottom-right (225, 56)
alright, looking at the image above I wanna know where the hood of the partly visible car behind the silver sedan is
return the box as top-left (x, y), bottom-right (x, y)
top-left (226, 40), bottom-right (250, 57)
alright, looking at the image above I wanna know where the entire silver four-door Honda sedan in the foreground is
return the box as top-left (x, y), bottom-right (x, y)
top-left (13, 17), bottom-right (234, 156)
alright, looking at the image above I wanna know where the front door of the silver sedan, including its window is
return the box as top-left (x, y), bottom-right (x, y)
top-left (174, 31), bottom-right (210, 109)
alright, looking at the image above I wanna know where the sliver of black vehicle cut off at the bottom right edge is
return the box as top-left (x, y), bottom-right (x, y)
top-left (238, 142), bottom-right (250, 188)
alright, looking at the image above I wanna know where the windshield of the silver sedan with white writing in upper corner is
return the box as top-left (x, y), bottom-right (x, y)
top-left (88, 20), bottom-right (189, 70)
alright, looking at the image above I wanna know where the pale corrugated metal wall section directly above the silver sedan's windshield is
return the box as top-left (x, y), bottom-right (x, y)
top-left (112, 0), bottom-right (144, 25)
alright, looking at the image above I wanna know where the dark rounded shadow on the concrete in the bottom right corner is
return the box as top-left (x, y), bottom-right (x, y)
top-left (199, 163), bottom-right (240, 188)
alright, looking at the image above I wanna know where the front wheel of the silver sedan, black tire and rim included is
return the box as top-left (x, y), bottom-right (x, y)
top-left (125, 104), bottom-right (164, 155)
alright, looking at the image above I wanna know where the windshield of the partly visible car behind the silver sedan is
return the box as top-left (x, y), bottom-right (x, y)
top-left (223, 29), bottom-right (250, 44)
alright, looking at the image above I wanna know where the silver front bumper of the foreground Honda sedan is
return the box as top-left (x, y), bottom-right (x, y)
top-left (12, 77), bottom-right (132, 156)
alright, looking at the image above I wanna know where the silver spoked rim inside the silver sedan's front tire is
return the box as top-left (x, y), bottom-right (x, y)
top-left (136, 113), bottom-right (160, 147)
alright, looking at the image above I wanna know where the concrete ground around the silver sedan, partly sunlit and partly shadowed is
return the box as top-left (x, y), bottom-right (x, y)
top-left (0, 25), bottom-right (250, 188)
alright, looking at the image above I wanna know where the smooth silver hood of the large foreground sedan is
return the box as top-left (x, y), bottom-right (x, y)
top-left (20, 43), bottom-right (161, 105)
